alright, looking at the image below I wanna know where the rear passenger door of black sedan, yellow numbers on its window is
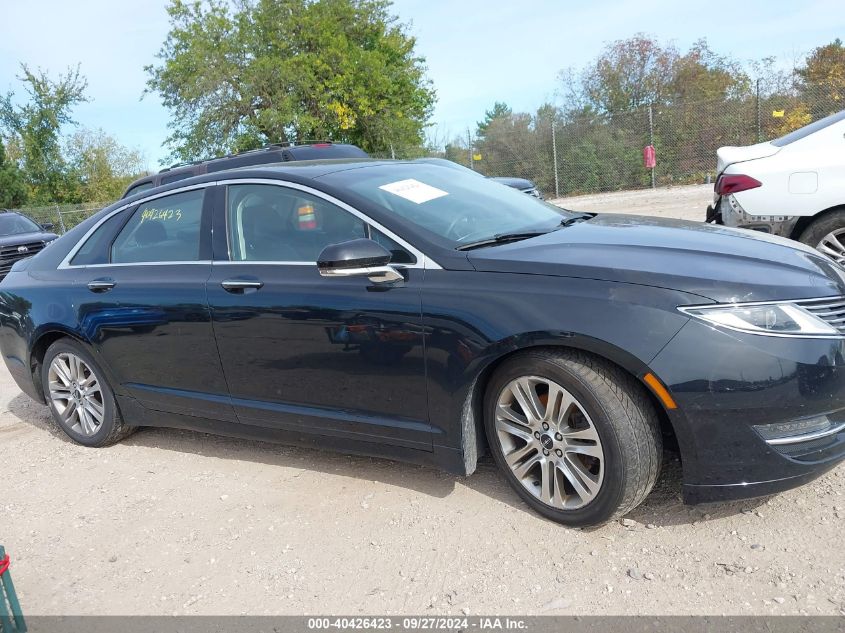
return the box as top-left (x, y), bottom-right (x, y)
top-left (69, 189), bottom-right (235, 422)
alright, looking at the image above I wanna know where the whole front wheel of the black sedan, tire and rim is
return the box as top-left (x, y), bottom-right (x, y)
top-left (484, 350), bottom-right (663, 527)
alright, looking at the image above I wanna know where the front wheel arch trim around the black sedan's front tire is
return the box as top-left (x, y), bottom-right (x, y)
top-left (461, 337), bottom-right (677, 474)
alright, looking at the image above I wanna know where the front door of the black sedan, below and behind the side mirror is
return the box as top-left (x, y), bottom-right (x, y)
top-left (208, 184), bottom-right (431, 450)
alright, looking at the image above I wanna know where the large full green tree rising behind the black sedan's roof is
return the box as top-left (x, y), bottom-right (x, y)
top-left (146, 0), bottom-right (435, 159)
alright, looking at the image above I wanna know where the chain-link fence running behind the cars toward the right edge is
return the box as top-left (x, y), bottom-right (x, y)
top-left (395, 84), bottom-right (845, 198)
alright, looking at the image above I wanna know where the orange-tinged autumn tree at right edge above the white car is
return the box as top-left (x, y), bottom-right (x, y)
top-left (797, 38), bottom-right (845, 118)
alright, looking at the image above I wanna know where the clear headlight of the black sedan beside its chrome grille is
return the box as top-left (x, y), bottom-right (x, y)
top-left (678, 303), bottom-right (840, 337)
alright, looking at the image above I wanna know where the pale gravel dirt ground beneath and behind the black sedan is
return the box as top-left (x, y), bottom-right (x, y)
top-left (0, 187), bottom-right (845, 615)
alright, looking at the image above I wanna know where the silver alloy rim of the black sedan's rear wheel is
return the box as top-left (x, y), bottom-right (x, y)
top-left (47, 352), bottom-right (105, 436)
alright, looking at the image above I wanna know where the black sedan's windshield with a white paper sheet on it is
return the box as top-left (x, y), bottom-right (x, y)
top-left (321, 163), bottom-right (574, 246)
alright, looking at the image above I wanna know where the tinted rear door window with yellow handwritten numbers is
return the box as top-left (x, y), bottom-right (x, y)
top-left (111, 189), bottom-right (204, 263)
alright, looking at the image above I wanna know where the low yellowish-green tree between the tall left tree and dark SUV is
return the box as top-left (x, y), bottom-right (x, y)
top-left (65, 128), bottom-right (146, 202)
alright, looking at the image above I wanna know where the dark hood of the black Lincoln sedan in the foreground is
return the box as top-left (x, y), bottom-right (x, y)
top-left (467, 214), bottom-right (845, 302)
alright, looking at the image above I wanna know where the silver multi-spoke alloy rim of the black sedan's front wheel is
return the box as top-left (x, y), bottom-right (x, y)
top-left (495, 376), bottom-right (604, 510)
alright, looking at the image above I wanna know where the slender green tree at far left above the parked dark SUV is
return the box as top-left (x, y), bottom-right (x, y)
top-left (0, 64), bottom-right (88, 204)
